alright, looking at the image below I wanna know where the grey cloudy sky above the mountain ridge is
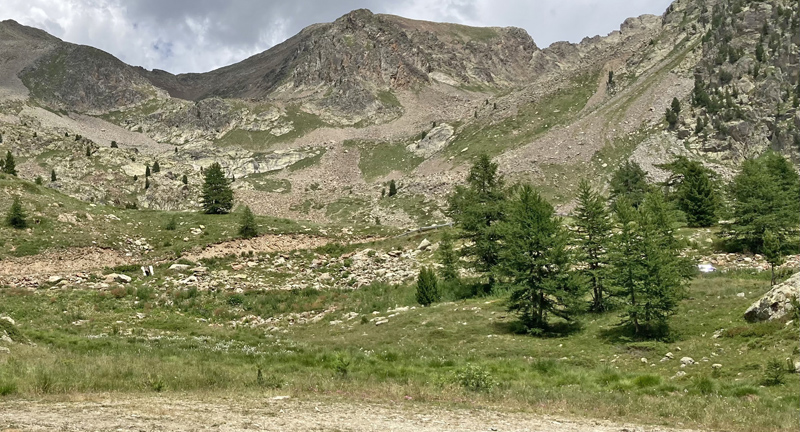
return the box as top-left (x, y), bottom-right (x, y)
top-left (0, 0), bottom-right (671, 73)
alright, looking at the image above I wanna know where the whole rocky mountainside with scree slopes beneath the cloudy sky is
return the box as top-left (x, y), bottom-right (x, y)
top-left (0, 0), bottom-right (800, 226)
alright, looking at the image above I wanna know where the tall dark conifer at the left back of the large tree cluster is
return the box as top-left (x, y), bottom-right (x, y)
top-left (448, 154), bottom-right (505, 286)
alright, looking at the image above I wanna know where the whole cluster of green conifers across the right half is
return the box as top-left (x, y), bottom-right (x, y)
top-left (417, 153), bottom-right (800, 337)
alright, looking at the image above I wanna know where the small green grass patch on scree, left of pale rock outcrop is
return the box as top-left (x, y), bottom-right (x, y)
top-left (344, 140), bottom-right (425, 182)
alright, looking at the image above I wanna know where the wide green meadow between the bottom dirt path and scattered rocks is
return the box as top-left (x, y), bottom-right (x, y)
top-left (0, 230), bottom-right (800, 431)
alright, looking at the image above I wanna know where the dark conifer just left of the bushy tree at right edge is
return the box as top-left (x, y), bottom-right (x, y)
top-left (662, 156), bottom-right (721, 227)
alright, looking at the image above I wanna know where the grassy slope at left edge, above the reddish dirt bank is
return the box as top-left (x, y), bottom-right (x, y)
top-left (0, 176), bottom-right (319, 260)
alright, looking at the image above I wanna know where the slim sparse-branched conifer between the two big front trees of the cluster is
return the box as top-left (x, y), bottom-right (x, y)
top-left (573, 180), bottom-right (611, 312)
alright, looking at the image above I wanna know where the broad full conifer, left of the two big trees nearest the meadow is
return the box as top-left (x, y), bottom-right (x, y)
top-left (498, 185), bottom-right (584, 333)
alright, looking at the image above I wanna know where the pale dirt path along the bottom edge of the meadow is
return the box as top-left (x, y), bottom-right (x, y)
top-left (0, 395), bottom-right (700, 432)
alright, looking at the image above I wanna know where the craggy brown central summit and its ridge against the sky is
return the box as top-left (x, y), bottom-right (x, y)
top-left (137, 9), bottom-right (538, 113)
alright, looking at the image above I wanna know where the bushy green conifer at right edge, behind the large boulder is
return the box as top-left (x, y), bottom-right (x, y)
top-left (725, 152), bottom-right (800, 252)
